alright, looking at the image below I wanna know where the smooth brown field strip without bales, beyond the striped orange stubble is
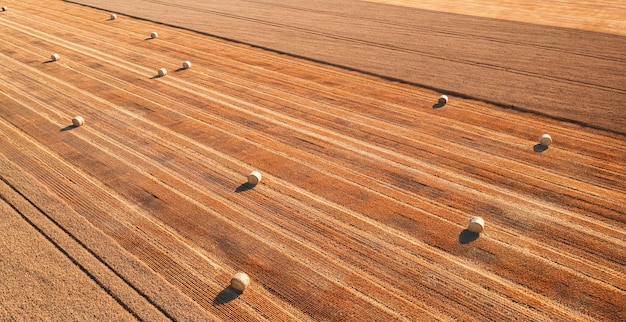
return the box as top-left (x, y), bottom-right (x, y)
top-left (63, 0), bottom-right (626, 135)
